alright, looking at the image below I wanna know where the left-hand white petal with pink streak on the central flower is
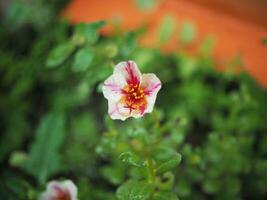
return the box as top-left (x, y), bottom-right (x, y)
top-left (103, 74), bottom-right (124, 101)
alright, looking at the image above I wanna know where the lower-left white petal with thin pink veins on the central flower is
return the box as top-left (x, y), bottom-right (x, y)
top-left (108, 101), bottom-right (130, 121)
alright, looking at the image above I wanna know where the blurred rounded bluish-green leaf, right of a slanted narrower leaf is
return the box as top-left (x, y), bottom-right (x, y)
top-left (72, 47), bottom-right (95, 72)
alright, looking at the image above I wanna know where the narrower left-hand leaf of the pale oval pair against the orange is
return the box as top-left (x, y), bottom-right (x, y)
top-left (158, 16), bottom-right (176, 43)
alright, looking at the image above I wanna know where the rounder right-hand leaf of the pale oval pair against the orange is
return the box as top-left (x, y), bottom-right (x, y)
top-left (180, 22), bottom-right (196, 44)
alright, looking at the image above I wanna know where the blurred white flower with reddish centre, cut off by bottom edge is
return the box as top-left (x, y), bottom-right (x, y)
top-left (39, 180), bottom-right (78, 200)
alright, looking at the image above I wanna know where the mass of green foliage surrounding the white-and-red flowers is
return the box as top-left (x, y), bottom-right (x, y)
top-left (0, 0), bottom-right (267, 200)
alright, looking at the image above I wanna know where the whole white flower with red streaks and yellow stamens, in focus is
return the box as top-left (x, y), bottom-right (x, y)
top-left (103, 61), bottom-right (161, 120)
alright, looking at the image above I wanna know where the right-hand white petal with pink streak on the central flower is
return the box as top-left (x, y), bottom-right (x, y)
top-left (141, 73), bottom-right (161, 113)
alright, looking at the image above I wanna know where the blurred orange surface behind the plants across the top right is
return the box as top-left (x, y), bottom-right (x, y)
top-left (63, 0), bottom-right (267, 87)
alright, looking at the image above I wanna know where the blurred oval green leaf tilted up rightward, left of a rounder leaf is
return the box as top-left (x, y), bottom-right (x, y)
top-left (46, 42), bottom-right (75, 68)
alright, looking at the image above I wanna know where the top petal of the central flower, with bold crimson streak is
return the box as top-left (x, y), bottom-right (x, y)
top-left (113, 60), bottom-right (141, 85)
